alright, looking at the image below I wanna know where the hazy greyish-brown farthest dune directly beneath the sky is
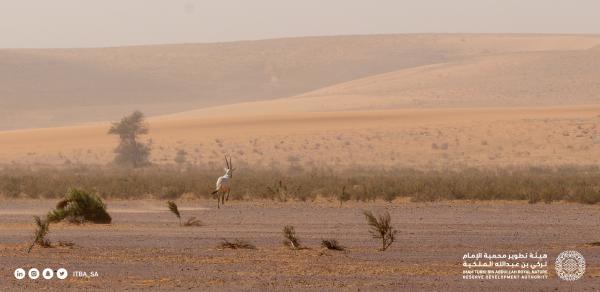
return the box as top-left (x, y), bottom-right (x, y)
top-left (0, 35), bottom-right (600, 130)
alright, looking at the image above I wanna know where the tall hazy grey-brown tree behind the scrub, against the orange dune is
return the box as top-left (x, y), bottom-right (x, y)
top-left (108, 111), bottom-right (150, 168)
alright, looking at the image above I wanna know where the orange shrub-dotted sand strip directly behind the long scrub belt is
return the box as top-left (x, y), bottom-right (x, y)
top-left (0, 105), bottom-right (600, 168)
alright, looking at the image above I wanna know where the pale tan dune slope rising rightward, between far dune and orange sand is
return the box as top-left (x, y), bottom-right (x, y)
top-left (169, 50), bottom-right (600, 116)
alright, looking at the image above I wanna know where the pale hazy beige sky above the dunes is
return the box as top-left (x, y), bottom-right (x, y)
top-left (0, 0), bottom-right (600, 48)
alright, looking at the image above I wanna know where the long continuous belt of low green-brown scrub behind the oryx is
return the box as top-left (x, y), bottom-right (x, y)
top-left (0, 161), bottom-right (600, 204)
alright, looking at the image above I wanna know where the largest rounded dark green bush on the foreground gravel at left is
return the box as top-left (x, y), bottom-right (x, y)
top-left (48, 189), bottom-right (112, 224)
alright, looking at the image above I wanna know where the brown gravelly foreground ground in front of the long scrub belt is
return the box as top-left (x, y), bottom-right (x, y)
top-left (0, 200), bottom-right (600, 291)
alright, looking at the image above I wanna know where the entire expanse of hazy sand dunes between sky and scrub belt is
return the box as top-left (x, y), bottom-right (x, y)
top-left (0, 35), bottom-right (600, 168)
